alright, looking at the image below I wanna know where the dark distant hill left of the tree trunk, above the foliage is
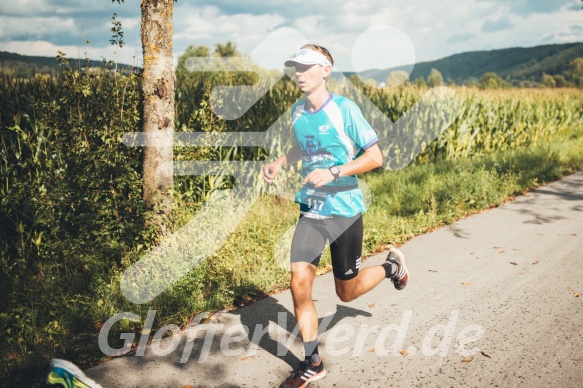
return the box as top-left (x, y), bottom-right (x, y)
top-left (0, 51), bottom-right (133, 77)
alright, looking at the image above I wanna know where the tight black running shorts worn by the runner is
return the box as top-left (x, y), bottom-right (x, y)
top-left (291, 214), bottom-right (363, 280)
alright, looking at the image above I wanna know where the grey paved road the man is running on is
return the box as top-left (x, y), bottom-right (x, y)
top-left (87, 173), bottom-right (583, 388)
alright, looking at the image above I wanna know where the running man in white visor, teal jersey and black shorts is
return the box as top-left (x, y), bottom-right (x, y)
top-left (262, 44), bottom-right (409, 388)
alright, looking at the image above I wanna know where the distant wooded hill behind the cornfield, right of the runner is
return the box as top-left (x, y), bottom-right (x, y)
top-left (346, 42), bottom-right (583, 84)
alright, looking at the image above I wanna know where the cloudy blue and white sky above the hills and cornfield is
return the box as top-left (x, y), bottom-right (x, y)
top-left (0, 0), bottom-right (583, 71)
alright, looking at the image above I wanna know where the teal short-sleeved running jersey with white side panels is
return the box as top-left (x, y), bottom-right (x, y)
top-left (292, 93), bottom-right (378, 218)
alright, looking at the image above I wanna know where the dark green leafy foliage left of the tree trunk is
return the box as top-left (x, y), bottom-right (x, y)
top-left (0, 56), bottom-right (152, 384)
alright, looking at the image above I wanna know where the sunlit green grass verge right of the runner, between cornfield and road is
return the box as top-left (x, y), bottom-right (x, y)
top-left (365, 137), bottom-right (583, 253)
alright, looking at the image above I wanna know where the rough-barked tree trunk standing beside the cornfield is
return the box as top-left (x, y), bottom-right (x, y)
top-left (141, 0), bottom-right (175, 214)
